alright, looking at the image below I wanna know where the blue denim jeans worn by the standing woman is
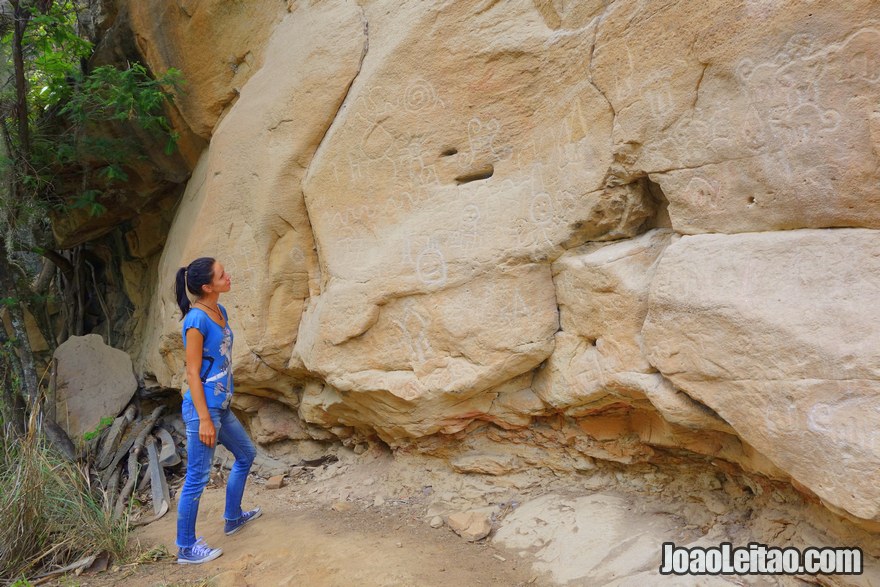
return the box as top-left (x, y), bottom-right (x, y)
top-left (177, 399), bottom-right (257, 548)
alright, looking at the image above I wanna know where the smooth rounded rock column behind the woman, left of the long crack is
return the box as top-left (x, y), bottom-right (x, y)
top-left (138, 4), bottom-right (364, 400)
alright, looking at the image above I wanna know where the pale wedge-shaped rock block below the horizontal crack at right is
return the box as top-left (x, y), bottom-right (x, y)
top-left (644, 229), bottom-right (880, 520)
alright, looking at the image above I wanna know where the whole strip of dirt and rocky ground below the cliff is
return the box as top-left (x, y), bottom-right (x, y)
top-left (53, 449), bottom-right (880, 587)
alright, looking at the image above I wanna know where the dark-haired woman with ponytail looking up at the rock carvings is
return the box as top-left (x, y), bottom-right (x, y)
top-left (175, 257), bottom-right (262, 564)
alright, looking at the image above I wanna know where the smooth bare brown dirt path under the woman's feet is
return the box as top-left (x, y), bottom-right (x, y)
top-left (79, 484), bottom-right (540, 587)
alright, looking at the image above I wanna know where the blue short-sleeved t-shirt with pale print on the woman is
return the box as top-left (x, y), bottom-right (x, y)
top-left (183, 304), bottom-right (233, 409)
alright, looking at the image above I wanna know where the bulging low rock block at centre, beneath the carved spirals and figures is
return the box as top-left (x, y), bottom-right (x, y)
top-left (296, 264), bottom-right (556, 437)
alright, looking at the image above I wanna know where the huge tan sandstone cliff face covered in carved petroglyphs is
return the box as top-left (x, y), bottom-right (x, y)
top-left (130, 0), bottom-right (880, 520)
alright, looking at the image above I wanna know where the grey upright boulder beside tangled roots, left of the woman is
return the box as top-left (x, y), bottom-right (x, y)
top-left (53, 334), bottom-right (137, 439)
